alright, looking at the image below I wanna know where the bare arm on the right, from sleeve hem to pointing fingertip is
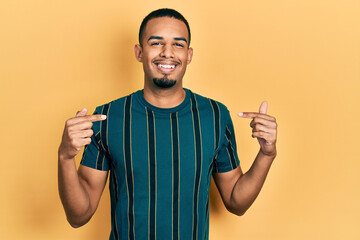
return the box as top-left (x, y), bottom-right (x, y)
top-left (213, 102), bottom-right (277, 215)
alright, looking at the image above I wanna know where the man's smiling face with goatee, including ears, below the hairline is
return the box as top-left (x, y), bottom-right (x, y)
top-left (135, 17), bottom-right (193, 88)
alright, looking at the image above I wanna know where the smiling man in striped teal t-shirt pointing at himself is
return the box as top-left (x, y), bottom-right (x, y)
top-left (58, 9), bottom-right (277, 239)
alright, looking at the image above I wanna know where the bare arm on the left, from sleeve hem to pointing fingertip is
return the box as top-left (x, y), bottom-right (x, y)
top-left (58, 109), bottom-right (108, 227)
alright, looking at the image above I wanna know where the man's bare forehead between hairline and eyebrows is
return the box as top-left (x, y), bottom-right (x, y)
top-left (144, 17), bottom-right (189, 40)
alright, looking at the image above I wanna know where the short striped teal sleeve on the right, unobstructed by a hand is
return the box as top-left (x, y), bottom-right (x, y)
top-left (214, 111), bottom-right (240, 173)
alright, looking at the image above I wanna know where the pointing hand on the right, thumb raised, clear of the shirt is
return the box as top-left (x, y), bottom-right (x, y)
top-left (238, 101), bottom-right (277, 156)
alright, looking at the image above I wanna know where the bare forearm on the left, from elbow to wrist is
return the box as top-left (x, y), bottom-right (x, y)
top-left (58, 155), bottom-right (92, 227)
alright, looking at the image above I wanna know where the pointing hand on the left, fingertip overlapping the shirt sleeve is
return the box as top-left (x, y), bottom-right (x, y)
top-left (59, 108), bottom-right (106, 159)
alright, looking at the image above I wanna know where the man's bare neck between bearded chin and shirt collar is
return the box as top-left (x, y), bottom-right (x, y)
top-left (143, 84), bottom-right (186, 108)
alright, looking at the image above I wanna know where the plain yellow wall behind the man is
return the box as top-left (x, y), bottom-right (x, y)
top-left (0, 0), bottom-right (360, 240)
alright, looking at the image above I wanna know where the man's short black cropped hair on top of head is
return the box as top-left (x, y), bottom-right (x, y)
top-left (139, 8), bottom-right (191, 46)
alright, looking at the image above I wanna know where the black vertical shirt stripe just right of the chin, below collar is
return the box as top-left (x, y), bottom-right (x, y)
top-left (171, 113), bottom-right (180, 240)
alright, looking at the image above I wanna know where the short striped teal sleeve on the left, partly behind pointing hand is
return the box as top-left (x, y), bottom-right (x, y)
top-left (80, 106), bottom-right (110, 171)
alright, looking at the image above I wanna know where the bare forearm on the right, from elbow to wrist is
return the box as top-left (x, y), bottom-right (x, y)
top-left (229, 151), bottom-right (276, 215)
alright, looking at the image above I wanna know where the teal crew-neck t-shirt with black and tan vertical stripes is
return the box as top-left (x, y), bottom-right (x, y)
top-left (81, 89), bottom-right (239, 240)
